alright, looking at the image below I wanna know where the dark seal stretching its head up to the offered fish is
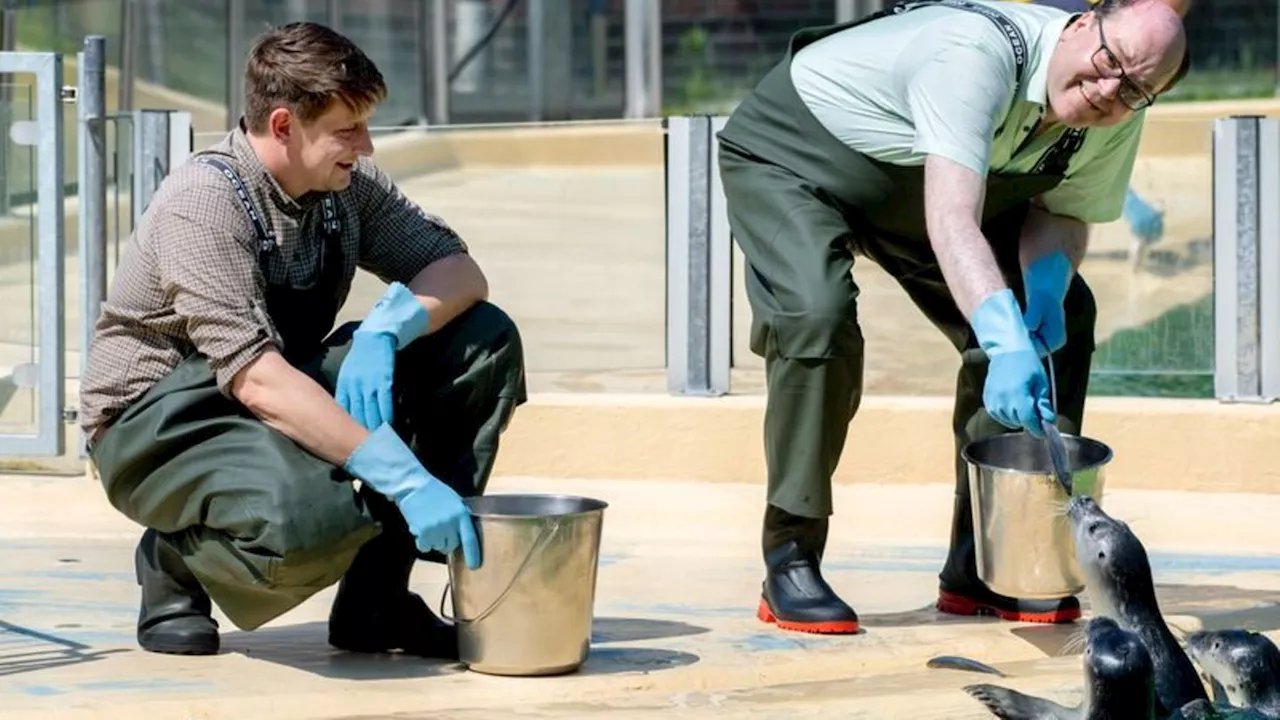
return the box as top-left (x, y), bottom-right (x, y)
top-left (1066, 496), bottom-right (1208, 717)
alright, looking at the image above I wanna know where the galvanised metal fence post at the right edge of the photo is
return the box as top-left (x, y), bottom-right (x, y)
top-left (1213, 115), bottom-right (1280, 402)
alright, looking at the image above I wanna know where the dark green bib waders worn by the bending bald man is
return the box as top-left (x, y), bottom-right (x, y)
top-left (718, 1), bottom-right (1096, 632)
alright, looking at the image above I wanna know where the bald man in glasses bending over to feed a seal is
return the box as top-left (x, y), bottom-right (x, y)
top-left (719, 0), bottom-right (1185, 633)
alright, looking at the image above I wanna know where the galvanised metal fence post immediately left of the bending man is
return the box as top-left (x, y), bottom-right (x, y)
top-left (666, 115), bottom-right (732, 396)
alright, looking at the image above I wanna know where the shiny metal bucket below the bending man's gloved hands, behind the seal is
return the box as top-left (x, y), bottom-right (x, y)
top-left (961, 433), bottom-right (1111, 600)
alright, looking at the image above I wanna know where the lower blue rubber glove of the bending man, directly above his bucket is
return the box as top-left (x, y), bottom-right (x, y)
top-left (973, 288), bottom-right (1057, 437)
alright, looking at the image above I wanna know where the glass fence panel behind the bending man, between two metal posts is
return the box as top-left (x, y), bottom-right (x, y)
top-left (733, 115), bottom-right (1213, 397)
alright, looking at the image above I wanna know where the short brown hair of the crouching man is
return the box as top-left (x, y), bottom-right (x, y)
top-left (244, 22), bottom-right (387, 133)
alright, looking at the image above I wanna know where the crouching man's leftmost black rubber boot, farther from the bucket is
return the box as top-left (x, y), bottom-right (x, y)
top-left (133, 528), bottom-right (220, 655)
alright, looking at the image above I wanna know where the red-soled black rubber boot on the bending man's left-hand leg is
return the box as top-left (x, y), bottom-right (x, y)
top-left (756, 505), bottom-right (858, 634)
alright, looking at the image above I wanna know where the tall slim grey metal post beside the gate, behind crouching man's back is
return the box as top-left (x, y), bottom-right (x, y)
top-left (76, 35), bottom-right (106, 404)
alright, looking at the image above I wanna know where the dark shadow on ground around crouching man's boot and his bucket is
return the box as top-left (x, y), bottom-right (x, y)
top-left (215, 609), bottom-right (709, 680)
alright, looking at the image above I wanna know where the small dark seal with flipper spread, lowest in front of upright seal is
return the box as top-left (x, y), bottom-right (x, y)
top-left (964, 609), bottom-right (1156, 720)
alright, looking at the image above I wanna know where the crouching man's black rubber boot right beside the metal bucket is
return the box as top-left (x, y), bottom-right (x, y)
top-left (329, 488), bottom-right (458, 660)
